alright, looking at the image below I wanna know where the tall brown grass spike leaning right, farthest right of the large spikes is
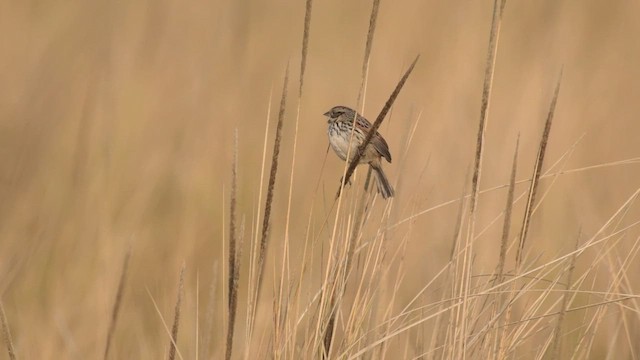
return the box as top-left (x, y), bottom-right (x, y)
top-left (516, 71), bottom-right (562, 269)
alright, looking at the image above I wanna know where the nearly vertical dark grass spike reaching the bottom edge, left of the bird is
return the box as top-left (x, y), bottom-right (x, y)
top-left (225, 129), bottom-right (240, 359)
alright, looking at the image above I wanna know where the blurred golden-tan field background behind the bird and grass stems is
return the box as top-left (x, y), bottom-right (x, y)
top-left (0, 0), bottom-right (640, 359)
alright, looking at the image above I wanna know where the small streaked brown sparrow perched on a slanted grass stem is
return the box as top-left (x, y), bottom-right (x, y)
top-left (324, 106), bottom-right (395, 199)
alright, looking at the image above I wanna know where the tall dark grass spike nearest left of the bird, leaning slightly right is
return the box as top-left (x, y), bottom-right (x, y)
top-left (254, 65), bottom-right (289, 315)
